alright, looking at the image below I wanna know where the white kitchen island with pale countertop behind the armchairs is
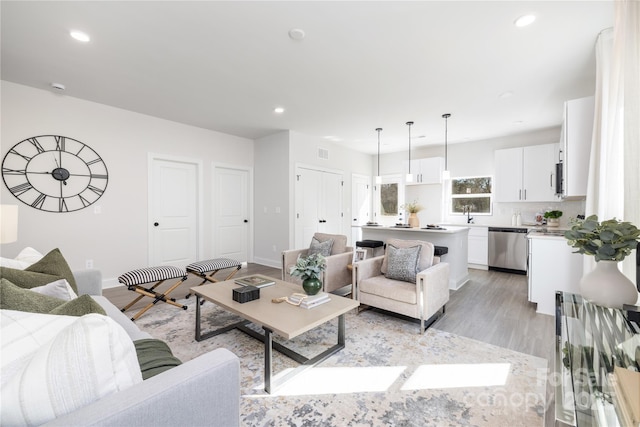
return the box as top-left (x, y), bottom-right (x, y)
top-left (362, 225), bottom-right (469, 290)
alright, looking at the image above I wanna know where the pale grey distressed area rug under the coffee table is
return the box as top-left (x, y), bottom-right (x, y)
top-left (136, 298), bottom-right (547, 427)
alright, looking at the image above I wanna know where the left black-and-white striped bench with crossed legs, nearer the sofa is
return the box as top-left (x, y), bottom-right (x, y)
top-left (118, 265), bottom-right (187, 321)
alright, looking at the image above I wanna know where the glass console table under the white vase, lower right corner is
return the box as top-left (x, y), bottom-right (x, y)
top-left (552, 292), bottom-right (640, 427)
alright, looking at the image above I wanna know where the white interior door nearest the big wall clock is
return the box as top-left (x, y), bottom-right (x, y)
top-left (149, 158), bottom-right (199, 267)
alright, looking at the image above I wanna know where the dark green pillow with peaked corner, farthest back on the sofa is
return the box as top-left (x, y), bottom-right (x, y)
top-left (0, 249), bottom-right (78, 294)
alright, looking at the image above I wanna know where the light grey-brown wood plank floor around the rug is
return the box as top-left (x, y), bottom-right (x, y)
top-left (104, 264), bottom-right (557, 426)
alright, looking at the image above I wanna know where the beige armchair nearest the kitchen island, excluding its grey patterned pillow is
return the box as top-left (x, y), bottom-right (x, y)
top-left (353, 239), bottom-right (449, 334)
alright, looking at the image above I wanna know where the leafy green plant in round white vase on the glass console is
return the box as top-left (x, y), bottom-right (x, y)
top-left (564, 215), bottom-right (640, 308)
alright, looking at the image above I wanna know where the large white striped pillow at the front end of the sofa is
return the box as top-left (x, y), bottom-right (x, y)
top-left (0, 314), bottom-right (142, 425)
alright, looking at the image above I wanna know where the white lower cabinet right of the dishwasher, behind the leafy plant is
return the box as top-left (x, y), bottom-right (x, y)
top-left (528, 235), bottom-right (583, 316)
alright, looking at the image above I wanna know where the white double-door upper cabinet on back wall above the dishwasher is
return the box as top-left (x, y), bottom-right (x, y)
top-left (494, 144), bottom-right (557, 202)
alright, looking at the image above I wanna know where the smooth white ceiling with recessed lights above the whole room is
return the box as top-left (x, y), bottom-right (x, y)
top-left (1, 1), bottom-right (614, 153)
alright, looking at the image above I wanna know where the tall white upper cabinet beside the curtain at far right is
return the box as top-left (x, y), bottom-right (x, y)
top-left (560, 96), bottom-right (594, 198)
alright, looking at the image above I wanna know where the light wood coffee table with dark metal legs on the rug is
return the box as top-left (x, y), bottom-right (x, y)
top-left (191, 279), bottom-right (360, 393)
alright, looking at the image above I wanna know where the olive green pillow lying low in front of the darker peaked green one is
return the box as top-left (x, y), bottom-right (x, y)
top-left (0, 278), bottom-right (106, 316)
